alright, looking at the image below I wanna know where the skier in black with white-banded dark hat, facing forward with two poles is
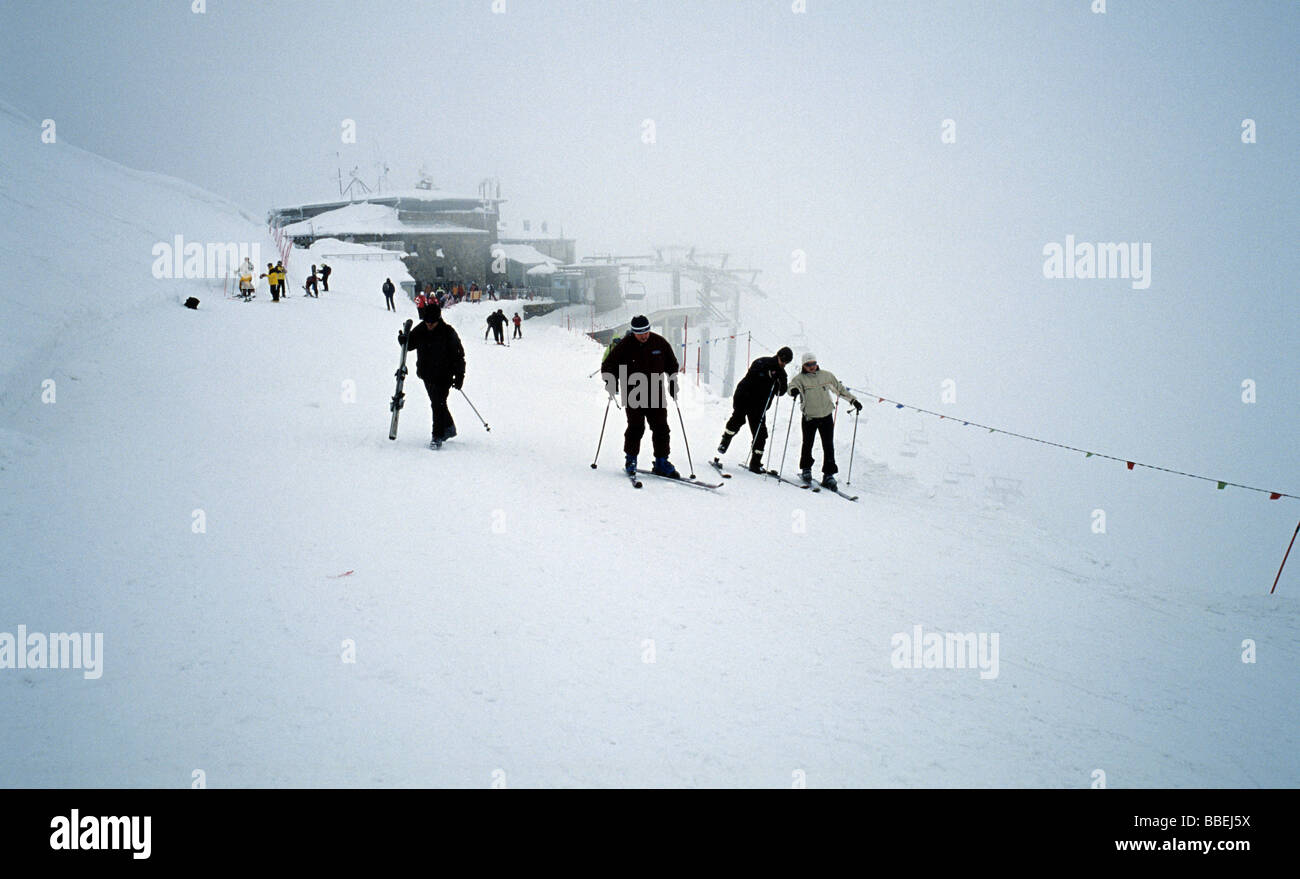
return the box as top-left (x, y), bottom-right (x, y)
top-left (601, 315), bottom-right (681, 479)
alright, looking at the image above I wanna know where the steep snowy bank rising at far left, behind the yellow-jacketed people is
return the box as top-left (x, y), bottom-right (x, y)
top-left (0, 101), bottom-right (274, 395)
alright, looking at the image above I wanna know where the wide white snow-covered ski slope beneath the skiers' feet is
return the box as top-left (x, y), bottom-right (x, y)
top-left (0, 106), bottom-right (1300, 787)
